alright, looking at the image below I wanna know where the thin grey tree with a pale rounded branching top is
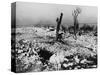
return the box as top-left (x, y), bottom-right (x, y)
top-left (72, 7), bottom-right (81, 39)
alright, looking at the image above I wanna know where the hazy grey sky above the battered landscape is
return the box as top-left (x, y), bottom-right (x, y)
top-left (16, 2), bottom-right (98, 25)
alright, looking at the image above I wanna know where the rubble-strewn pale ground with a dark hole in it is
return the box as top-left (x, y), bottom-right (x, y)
top-left (12, 27), bottom-right (97, 72)
